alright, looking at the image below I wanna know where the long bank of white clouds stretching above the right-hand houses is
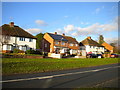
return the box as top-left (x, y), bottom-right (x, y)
top-left (56, 17), bottom-right (118, 37)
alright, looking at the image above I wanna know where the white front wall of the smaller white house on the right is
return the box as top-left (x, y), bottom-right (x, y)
top-left (85, 45), bottom-right (105, 54)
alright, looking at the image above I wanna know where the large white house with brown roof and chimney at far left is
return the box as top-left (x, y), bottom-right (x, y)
top-left (0, 22), bottom-right (36, 52)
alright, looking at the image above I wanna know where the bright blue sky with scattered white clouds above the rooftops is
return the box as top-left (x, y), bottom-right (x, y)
top-left (0, 2), bottom-right (119, 43)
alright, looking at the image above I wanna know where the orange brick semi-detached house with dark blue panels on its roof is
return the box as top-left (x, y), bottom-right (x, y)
top-left (44, 32), bottom-right (79, 54)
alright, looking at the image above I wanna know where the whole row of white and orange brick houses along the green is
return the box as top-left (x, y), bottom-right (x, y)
top-left (0, 22), bottom-right (113, 56)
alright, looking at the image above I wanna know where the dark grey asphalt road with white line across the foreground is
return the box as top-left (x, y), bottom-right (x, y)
top-left (0, 64), bottom-right (120, 89)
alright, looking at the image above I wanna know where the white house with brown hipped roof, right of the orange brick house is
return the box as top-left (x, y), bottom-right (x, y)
top-left (79, 37), bottom-right (105, 54)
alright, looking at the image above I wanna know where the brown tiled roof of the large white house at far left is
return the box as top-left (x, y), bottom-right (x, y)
top-left (0, 24), bottom-right (36, 39)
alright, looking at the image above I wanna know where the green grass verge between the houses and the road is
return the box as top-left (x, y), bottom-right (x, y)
top-left (2, 58), bottom-right (120, 75)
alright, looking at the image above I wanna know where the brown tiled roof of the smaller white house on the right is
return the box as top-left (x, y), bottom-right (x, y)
top-left (80, 38), bottom-right (103, 47)
